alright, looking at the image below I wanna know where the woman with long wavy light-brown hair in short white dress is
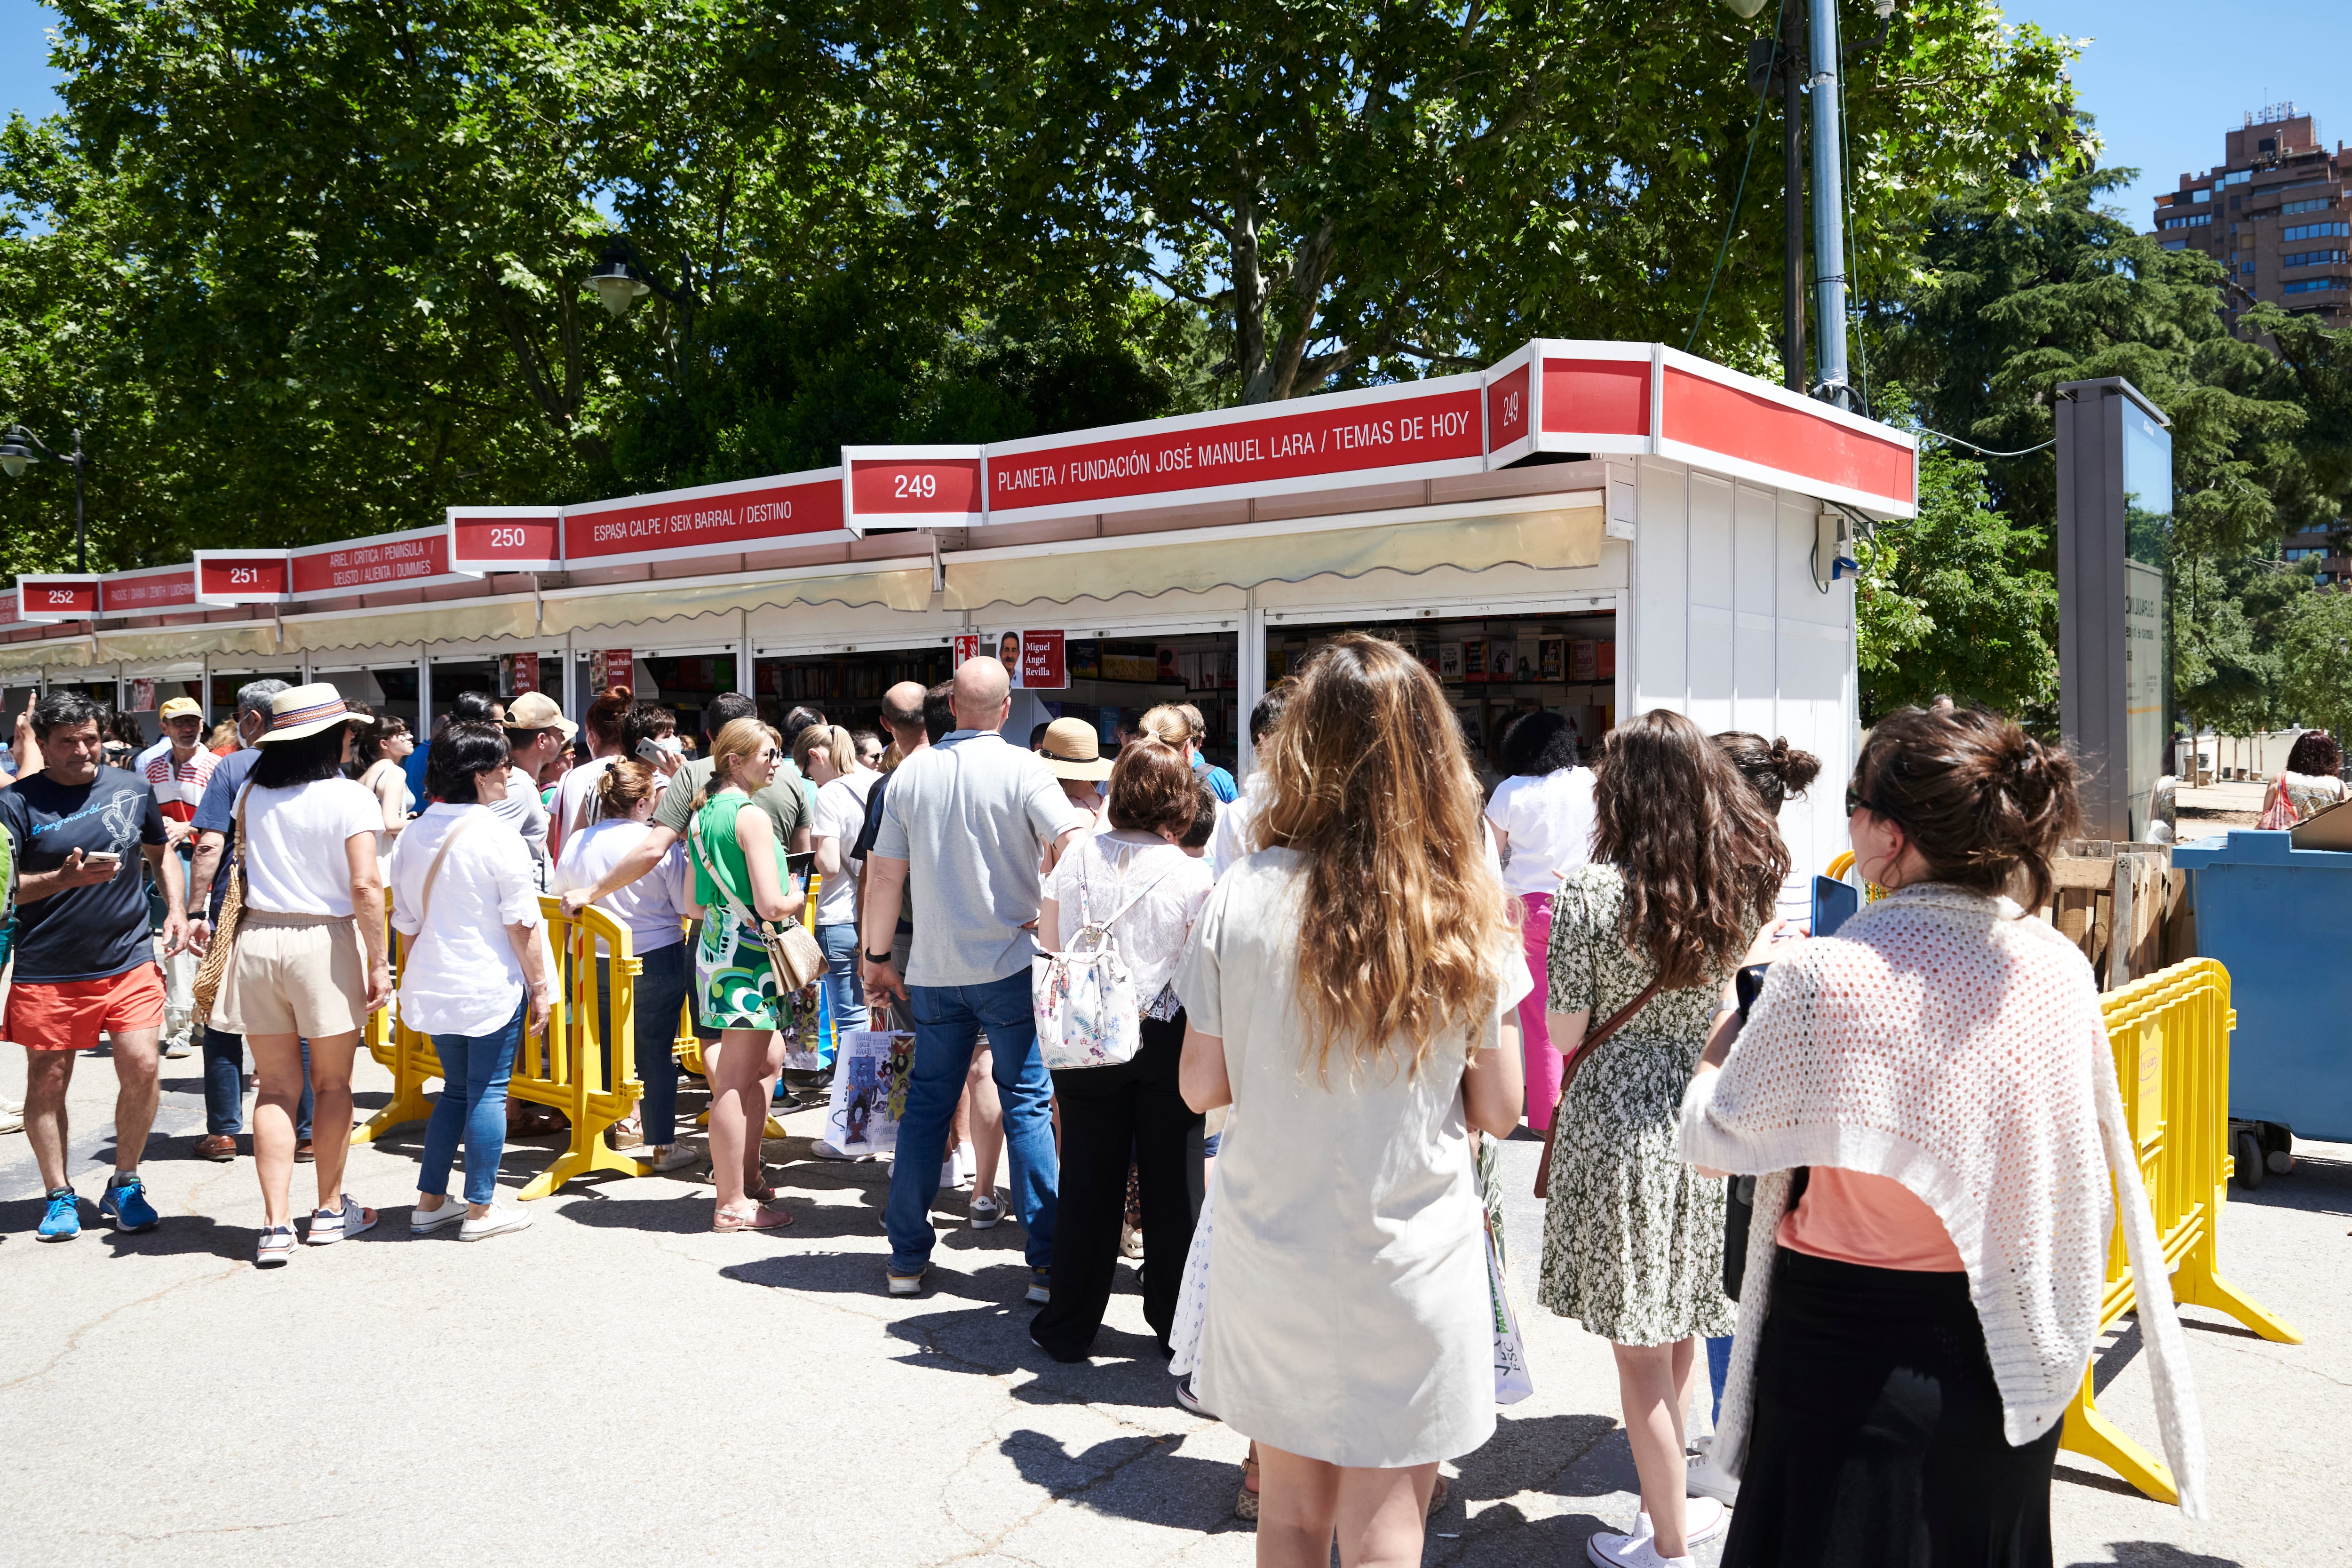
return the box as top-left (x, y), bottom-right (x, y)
top-left (1176, 635), bottom-right (1529, 1568)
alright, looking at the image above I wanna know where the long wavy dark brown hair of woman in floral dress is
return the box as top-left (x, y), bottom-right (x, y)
top-left (1592, 708), bottom-right (1788, 990)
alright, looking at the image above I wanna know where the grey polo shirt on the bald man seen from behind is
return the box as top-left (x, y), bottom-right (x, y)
top-left (875, 729), bottom-right (1091, 985)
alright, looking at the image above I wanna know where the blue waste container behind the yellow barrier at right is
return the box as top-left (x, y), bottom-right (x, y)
top-left (2173, 828), bottom-right (2352, 1152)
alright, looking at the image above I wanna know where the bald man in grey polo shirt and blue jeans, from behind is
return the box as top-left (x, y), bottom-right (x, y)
top-left (858, 656), bottom-right (1091, 1302)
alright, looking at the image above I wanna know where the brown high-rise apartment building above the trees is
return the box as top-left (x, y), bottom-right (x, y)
top-left (2152, 103), bottom-right (2352, 327)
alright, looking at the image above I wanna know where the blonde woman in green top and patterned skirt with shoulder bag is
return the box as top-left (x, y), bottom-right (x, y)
top-left (687, 719), bottom-right (793, 1229)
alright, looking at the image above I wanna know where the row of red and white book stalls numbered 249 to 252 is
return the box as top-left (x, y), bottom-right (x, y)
top-left (0, 339), bottom-right (1917, 868)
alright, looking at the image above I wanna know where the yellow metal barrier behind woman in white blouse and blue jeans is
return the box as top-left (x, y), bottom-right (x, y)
top-left (350, 896), bottom-right (647, 1199)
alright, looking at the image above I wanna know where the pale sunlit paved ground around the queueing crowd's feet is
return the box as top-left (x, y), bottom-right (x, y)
top-left (0, 1049), bottom-right (2352, 1568)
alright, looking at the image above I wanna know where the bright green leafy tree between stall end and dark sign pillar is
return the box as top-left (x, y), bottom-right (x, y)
top-left (1853, 430), bottom-right (2058, 724)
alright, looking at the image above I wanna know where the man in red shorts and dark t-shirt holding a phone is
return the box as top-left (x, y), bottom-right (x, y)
top-left (0, 691), bottom-right (188, 1241)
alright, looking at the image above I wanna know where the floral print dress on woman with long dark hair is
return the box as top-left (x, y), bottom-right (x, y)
top-left (1536, 865), bottom-right (1736, 1345)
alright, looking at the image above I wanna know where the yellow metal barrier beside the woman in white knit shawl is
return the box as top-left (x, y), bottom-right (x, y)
top-left (2058, 959), bottom-right (2303, 1502)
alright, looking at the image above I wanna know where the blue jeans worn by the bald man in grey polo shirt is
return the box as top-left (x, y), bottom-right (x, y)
top-left (882, 966), bottom-right (1061, 1274)
